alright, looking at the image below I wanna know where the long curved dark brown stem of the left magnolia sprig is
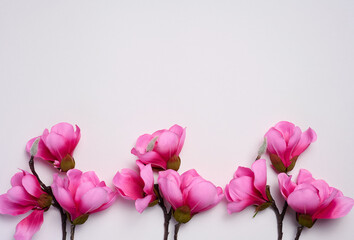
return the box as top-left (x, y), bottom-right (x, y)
top-left (28, 156), bottom-right (67, 240)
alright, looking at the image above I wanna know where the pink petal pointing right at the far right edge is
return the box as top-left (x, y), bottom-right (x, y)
top-left (314, 197), bottom-right (354, 219)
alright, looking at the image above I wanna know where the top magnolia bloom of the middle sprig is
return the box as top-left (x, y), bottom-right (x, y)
top-left (131, 125), bottom-right (186, 171)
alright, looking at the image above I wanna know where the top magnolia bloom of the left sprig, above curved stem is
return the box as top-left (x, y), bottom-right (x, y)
top-left (26, 122), bottom-right (81, 171)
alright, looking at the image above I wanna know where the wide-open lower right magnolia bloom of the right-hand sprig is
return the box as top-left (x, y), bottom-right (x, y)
top-left (278, 169), bottom-right (354, 225)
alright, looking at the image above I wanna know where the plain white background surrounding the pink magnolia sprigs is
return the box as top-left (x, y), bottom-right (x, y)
top-left (0, 0), bottom-right (354, 240)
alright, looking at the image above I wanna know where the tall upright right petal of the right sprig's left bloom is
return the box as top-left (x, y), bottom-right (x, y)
top-left (252, 159), bottom-right (268, 200)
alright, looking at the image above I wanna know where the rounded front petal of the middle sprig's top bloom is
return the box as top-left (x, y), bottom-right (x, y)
top-left (154, 131), bottom-right (179, 160)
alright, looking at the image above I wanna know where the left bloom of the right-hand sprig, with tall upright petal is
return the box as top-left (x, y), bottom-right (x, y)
top-left (225, 159), bottom-right (270, 214)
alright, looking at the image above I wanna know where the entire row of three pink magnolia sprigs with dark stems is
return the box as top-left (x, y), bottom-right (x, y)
top-left (0, 121), bottom-right (354, 240)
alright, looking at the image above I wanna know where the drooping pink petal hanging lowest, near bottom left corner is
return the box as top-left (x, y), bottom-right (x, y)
top-left (14, 210), bottom-right (44, 240)
